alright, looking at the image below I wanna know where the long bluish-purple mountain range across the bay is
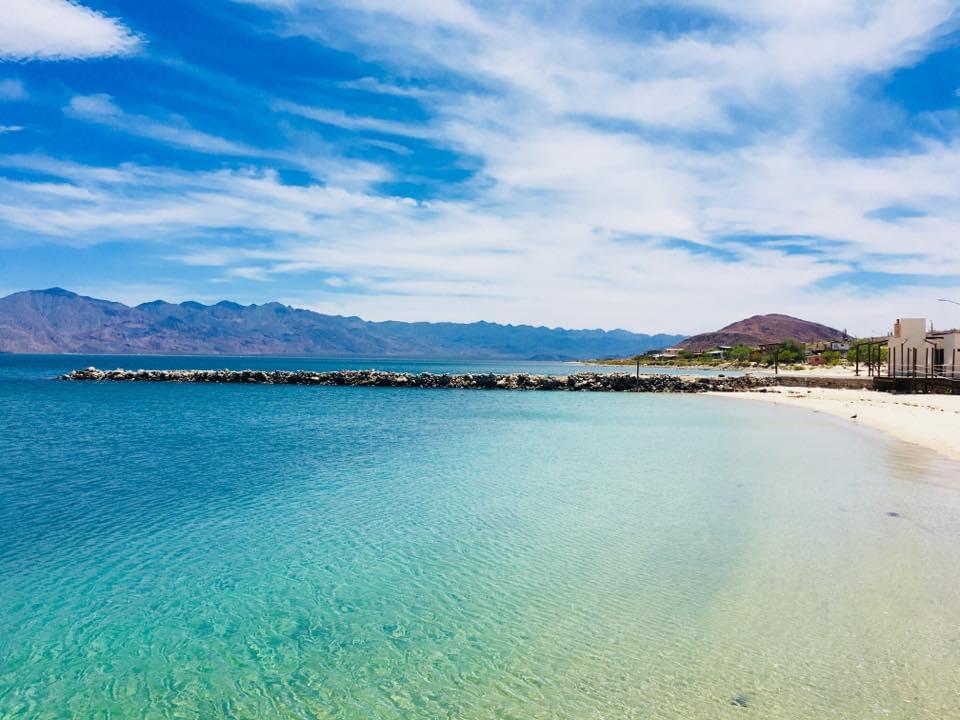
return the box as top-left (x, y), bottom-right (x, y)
top-left (0, 288), bottom-right (683, 360)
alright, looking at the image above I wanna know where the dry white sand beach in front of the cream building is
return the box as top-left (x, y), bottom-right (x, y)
top-left (711, 387), bottom-right (960, 460)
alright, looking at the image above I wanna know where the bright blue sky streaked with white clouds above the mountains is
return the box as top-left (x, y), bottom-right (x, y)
top-left (0, 0), bottom-right (960, 335)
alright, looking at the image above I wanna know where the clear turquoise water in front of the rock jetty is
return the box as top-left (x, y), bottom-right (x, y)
top-left (0, 356), bottom-right (960, 719)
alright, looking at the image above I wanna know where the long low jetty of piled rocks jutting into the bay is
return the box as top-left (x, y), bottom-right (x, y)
top-left (60, 367), bottom-right (774, 393)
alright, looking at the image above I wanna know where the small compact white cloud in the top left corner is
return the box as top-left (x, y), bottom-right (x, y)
top-left (0, 0), bottom-right (140, 60)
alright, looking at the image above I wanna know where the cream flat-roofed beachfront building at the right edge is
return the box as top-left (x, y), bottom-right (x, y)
top-left (887, 318), bottom-right (960, 378)
